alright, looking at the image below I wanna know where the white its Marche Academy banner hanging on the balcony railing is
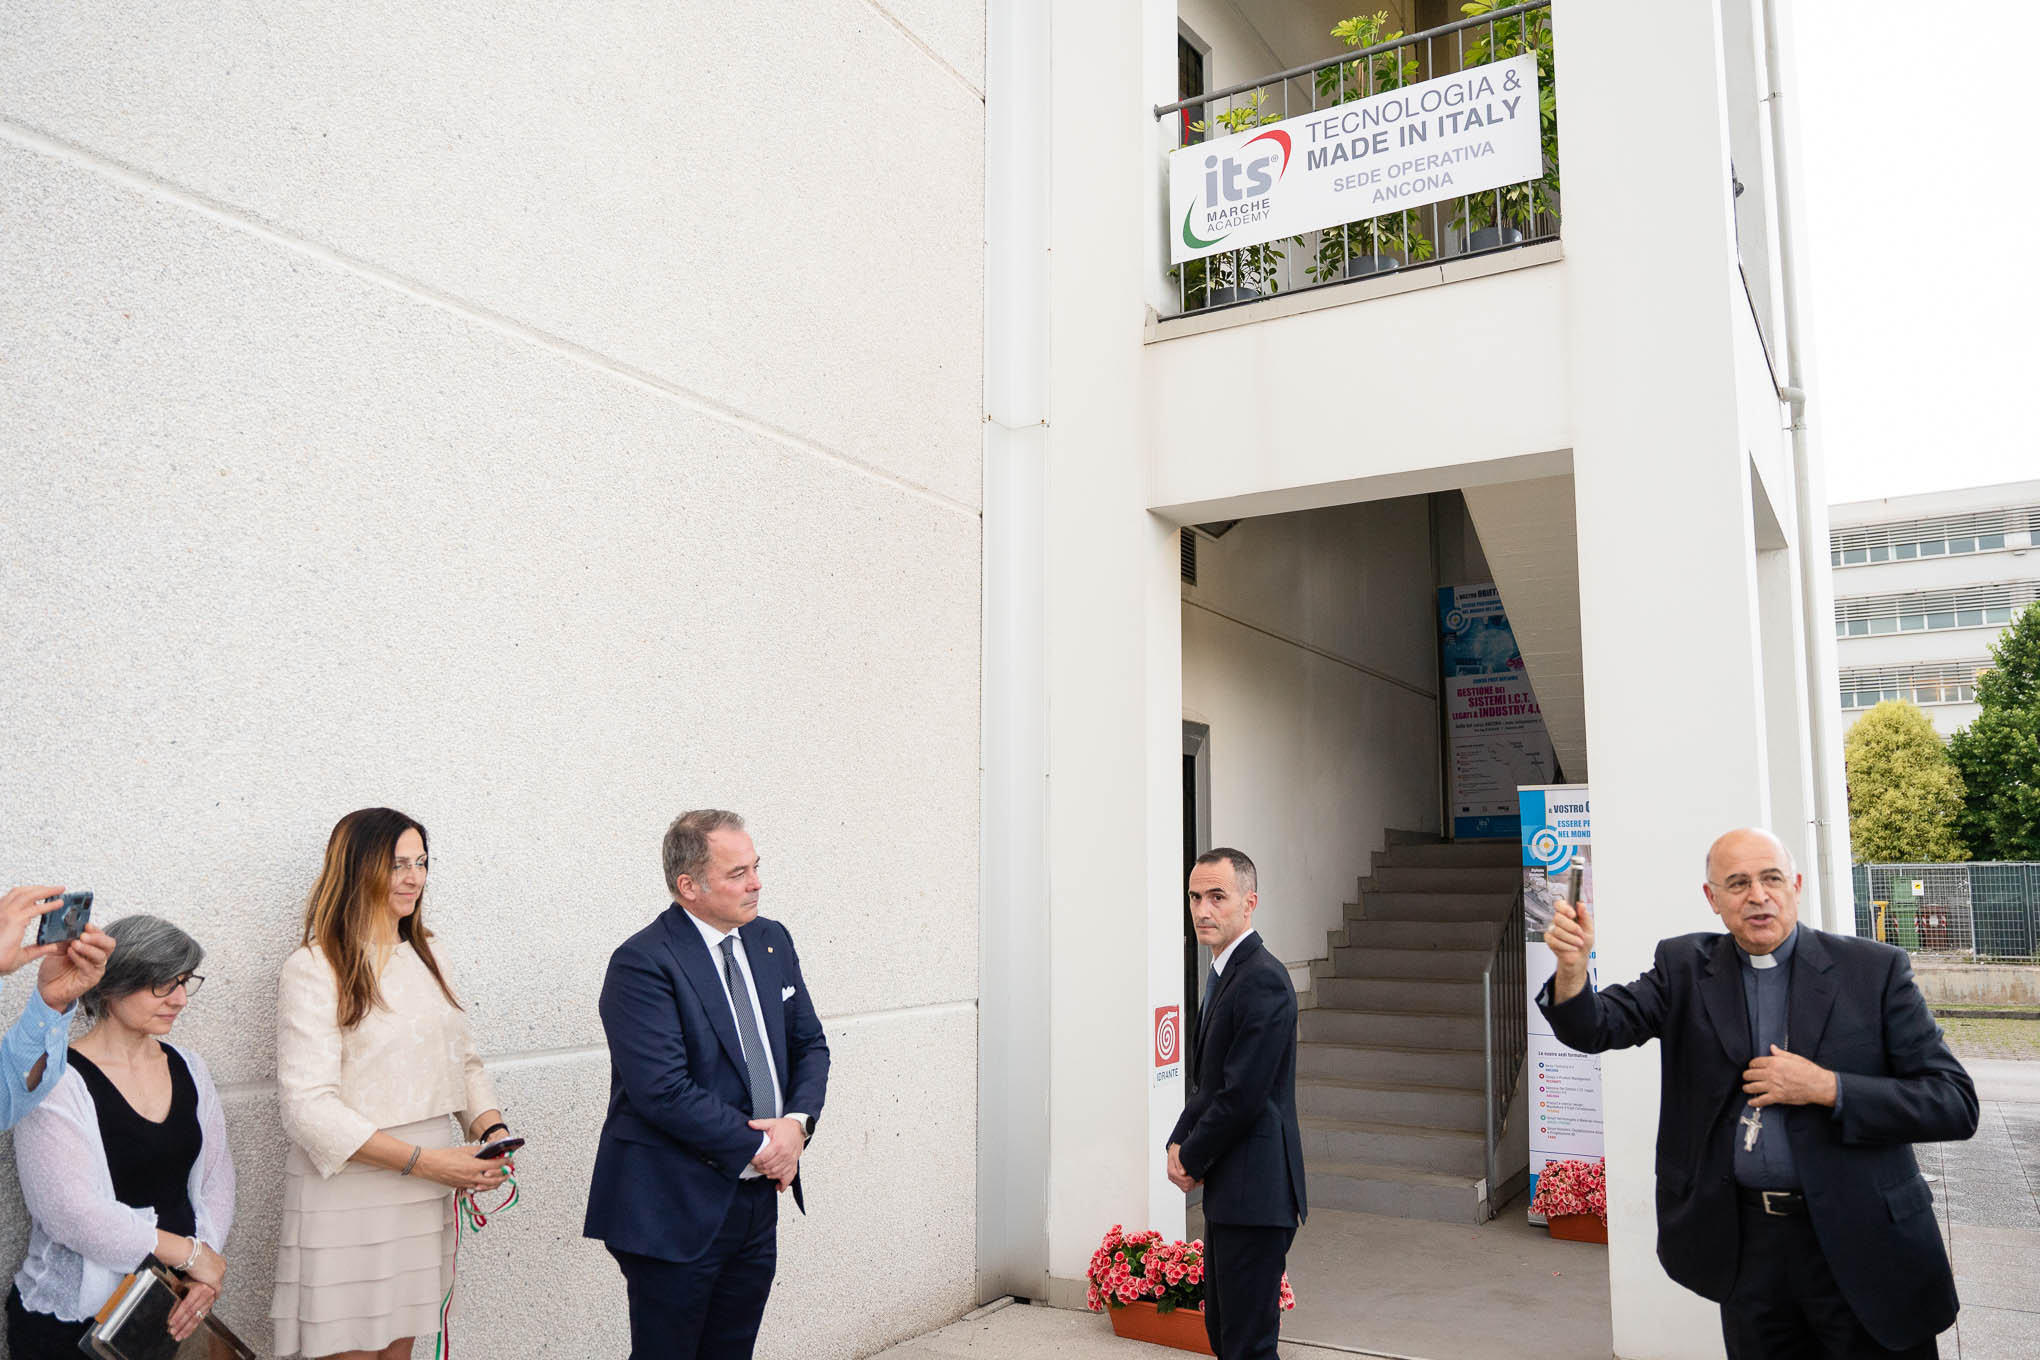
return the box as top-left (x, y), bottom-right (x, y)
top-left (1169, 55), bottom-right (1544, 265)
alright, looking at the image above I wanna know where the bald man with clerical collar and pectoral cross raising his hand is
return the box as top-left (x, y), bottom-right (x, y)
top-left (1538, 830), bottom-right (1977, 1360)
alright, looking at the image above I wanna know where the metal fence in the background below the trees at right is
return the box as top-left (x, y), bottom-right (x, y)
top-left (1850, 862), bottom-right (2040, 962)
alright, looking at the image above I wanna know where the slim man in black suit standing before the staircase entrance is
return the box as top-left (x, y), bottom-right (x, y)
top-left (1169, 848), bottom-right (1306, 1360)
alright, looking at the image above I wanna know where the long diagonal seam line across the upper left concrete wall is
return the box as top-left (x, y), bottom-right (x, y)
top-left (0, 118), bottom-right (979, 520)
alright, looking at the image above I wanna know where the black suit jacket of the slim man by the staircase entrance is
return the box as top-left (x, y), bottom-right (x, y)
top-left (1169, 934), bottom-right (1306, 1227)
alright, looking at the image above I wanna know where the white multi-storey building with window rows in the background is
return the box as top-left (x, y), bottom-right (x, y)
top-left (1828, 481), bottom-right (2040, 736)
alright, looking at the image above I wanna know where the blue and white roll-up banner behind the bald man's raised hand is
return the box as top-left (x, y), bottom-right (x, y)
top-left (1516, 783), bottom-right (1603, 1223)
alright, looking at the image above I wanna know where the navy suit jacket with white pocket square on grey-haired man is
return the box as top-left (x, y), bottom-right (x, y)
top-left (581, 903), bottom-right (828, 1264)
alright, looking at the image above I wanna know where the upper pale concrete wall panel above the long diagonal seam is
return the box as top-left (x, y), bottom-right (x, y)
top-left (0, 0), bottom-right (983, 506)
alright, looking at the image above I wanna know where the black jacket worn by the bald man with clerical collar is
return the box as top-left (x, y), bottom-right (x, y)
top-left (1538, 926), bottom-right (1977, 1350)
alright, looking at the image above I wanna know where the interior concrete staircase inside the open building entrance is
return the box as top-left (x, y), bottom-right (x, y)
top-left (1295, 832), bottom-right (1528, 1223)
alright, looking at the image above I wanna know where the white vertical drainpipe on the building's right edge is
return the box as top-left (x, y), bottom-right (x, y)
top-left (1761, 0), bottom-right (1854, 934)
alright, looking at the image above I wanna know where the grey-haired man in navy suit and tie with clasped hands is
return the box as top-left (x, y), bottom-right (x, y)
top-left (581, 809), bottom-right (828, 1360)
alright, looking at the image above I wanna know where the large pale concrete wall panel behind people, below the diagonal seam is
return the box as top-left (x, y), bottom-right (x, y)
top-left (0, 111), bottom-right (979, 1356)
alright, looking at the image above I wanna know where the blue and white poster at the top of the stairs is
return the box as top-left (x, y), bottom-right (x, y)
top-left (1438, 583), bottom-right (1557, 840)
